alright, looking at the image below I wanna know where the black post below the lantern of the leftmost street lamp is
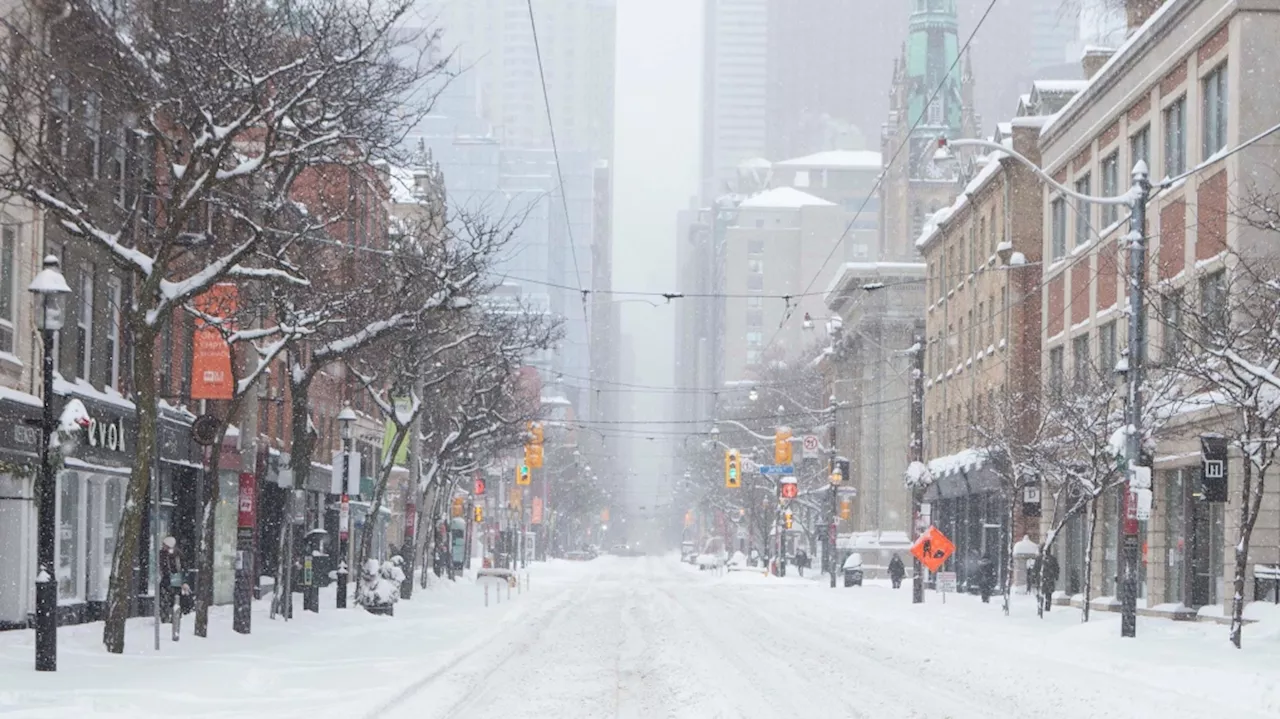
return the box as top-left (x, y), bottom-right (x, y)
top-left (36, 330), bottom-right (58, 672)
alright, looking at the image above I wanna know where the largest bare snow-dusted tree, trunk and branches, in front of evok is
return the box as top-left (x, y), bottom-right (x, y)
top-left (0, 0), bottom-right (443, 652)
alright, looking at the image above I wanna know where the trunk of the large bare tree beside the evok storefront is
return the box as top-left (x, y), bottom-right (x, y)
top-left (102, 319), bottom-right (160, 654)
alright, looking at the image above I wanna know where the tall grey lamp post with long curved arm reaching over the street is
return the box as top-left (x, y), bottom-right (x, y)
top-left (934, 132), bottom-right (1152, 637)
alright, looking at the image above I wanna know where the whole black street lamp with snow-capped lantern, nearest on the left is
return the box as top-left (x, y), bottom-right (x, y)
top-left (27, 255), bottom-right (72, 672)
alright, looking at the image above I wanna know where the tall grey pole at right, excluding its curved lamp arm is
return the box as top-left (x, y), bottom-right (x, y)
top-left (1120, 160), bottom-right (1151, 637)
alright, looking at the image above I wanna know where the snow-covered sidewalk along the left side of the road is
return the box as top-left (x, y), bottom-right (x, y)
top-left (0, 562), bottom-right (585, 719)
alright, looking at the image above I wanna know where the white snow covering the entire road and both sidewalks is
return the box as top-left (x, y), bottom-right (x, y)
top-left (0, 558), bottom-right (1280, 719)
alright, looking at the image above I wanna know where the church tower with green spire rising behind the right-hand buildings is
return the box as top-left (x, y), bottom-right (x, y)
top-left (879, 0), bottom-right (980, 261)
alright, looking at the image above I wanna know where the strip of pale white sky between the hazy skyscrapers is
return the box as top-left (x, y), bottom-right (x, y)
top-left (613, 0), bottom-right (703, 507)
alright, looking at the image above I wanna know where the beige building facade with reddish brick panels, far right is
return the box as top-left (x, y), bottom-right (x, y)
top-left (1041, 0), bottom-right (1280, 613)
